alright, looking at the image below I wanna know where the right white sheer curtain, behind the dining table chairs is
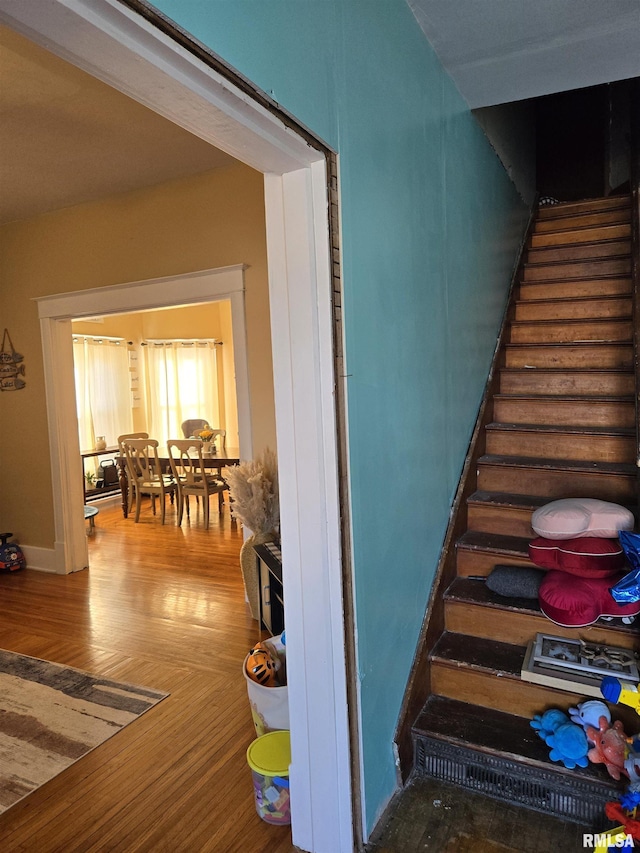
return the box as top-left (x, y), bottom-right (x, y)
top-left (144, 340), bottom-right (220, 445)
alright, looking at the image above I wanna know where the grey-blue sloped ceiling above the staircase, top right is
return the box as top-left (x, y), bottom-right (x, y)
top-left (407, 0), bottom-right (640, 109)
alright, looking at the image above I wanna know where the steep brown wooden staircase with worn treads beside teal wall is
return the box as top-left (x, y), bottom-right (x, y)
top-left (412, 196), bottom-right (639, 824)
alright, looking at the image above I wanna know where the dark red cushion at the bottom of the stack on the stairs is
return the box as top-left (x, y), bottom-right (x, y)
top-left (538, 571), bottom-right (640, 628)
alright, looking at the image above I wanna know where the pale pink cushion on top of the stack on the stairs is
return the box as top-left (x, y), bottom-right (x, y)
top-left (531, 498), bottom-right (634, 539)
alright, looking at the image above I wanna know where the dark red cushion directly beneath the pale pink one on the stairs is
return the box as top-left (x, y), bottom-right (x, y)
top-left (529, 536), bottom-right (626, 578)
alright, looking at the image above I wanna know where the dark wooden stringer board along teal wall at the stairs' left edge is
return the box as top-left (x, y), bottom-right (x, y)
top-left (394, 195), bottom-right (538, 787)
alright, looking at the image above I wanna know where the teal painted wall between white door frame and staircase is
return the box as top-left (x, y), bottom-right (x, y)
top-left (156, 0), bottom-right (526, 828)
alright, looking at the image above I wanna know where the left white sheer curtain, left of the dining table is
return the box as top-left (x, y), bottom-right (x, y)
top-left (73, 335), bottom-right (133, 450)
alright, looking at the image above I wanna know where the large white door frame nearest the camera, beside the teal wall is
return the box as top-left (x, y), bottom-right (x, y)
top-left (0, 0), bottom-right (353, 853)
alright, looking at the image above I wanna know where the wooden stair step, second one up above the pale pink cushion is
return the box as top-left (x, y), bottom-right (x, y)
top-left (486, 423), bottom-right (636, 463)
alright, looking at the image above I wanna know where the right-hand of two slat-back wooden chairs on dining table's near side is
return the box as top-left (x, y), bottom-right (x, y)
top-left (167, 438), bottom-right (229, 530)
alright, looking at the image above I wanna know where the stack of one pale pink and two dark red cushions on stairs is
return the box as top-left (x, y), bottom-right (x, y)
top-left (529, 498), bottom-right (640, 627)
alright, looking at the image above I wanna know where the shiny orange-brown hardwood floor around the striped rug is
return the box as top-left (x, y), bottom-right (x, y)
top-left (0, 504), bottom-right (295, 853)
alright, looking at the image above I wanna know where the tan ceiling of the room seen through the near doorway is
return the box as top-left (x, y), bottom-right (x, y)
top-left (0, 26), bottom-right (234, 223)
